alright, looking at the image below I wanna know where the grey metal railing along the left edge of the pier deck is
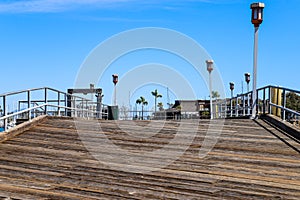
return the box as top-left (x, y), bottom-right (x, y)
top-left (0, 87), bottom-right (107, 130)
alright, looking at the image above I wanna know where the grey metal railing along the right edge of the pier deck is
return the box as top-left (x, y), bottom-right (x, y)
top-left (213, 85), bottom-right (300, 125)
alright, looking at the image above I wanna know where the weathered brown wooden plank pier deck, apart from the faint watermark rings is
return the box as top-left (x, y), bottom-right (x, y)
top-left (0, 117), bottom-right (300, 199)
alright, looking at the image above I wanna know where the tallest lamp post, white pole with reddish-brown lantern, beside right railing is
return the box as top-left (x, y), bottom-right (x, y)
top-left (250, 3), bottom-right (265, 119)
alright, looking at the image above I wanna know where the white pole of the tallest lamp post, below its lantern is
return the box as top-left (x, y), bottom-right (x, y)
top-left (252, 27), bottom-right (258, 119)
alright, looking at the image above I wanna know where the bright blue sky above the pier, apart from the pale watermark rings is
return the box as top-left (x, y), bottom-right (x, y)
top-left (0, 0), bottom-right (300, 109)
